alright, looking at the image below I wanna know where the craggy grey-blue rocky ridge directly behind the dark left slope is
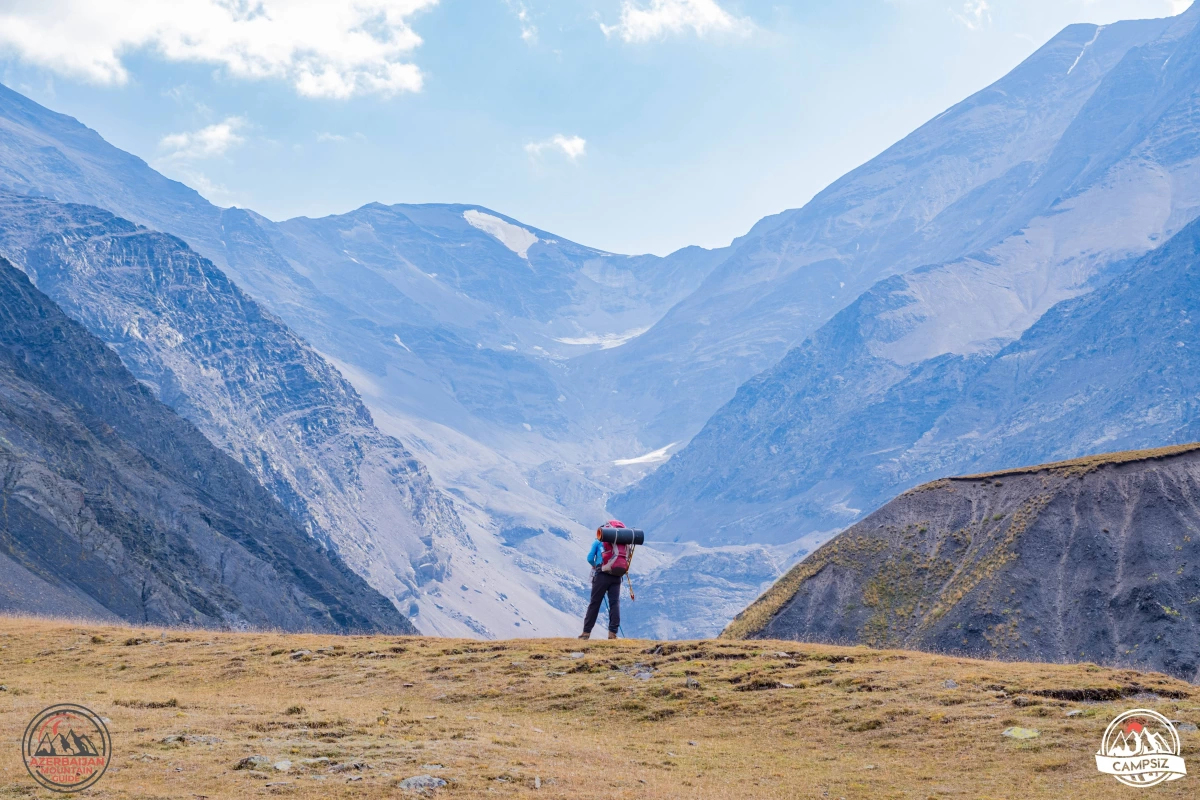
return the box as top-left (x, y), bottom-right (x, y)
top-left (0, 193), bottom-right (463, 612)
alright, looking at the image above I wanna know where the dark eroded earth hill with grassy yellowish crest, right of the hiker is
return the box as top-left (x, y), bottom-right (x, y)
top-left (725, 445), bottom-right (1200, 681)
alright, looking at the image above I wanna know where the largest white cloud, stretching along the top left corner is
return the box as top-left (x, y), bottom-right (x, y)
top-left (0, 0), bottom-right (438, 98)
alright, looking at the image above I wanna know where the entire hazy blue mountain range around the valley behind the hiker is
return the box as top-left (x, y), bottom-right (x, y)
top-left (0, 0), bottom-right (1200, 637)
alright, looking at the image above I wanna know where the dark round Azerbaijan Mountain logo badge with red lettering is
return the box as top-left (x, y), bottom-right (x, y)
top-left (22, 703), bottom-right (113, 792)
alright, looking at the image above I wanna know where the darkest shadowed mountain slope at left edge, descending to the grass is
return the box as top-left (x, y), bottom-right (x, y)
top-left (0, 259), bottom-right (414, 633)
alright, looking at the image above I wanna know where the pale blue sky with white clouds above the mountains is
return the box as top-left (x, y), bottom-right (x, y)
top-left (0, 0), bottom-right (1188, 253)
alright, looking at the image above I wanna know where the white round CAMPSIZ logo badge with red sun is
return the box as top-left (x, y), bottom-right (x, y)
top-left (1096, 709), bottom-right (1188, 789)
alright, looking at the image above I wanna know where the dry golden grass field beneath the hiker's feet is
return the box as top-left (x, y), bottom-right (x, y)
top-left (0, 619), bottom-right (1200, 800)
